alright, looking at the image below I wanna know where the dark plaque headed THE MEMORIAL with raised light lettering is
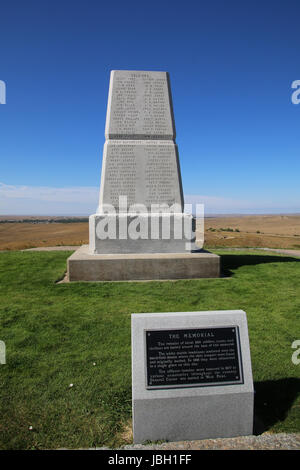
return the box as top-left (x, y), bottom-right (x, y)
top-left (145, 326), bottom-right (243, 389)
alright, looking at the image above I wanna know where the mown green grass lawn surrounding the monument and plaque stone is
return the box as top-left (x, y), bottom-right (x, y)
top-left (0, 251), bottom-right (300, 449)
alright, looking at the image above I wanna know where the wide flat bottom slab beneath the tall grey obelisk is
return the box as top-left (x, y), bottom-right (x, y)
top-left (67, 245), bottom-right (220, 281)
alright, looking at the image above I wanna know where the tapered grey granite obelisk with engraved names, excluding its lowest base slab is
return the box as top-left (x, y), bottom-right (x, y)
top-left (90, 70), bottom-right (194, 253)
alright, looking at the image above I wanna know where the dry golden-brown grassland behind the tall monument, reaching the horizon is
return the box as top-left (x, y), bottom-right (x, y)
top-left (0, 215), bottom-right (300, 250)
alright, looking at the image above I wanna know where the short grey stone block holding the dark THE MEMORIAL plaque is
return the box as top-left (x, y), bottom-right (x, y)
top-left (131, 310), bottom-right (254, 443)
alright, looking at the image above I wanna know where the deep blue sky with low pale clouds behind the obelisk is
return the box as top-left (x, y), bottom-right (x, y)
top-left (0, 0), bottom-right (300, 214)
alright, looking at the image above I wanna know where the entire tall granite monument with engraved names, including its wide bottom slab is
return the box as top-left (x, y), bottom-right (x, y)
top-left (68, 70), bottom-right (220, 281)
